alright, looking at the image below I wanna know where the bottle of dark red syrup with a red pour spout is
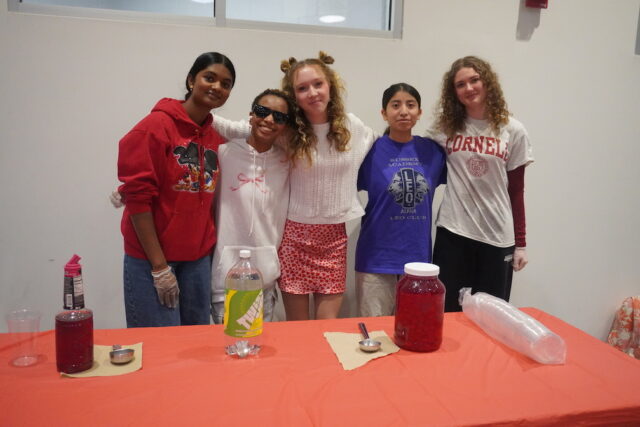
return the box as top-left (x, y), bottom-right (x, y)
top-left (56, 255), bottom-right (93, 374)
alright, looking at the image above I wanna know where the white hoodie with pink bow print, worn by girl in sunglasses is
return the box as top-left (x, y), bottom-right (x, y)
top-left (212, 139), bottom-right (289, 302)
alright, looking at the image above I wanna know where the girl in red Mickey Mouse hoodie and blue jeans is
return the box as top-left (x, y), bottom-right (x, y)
top-left (118, 52), bottom-right (235, 327)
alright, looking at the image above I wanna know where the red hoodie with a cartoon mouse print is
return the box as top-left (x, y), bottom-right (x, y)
top-left (118, 98), bottom-right (223, 261)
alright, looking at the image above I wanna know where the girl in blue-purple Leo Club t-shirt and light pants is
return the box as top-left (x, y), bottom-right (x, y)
top-left (355, 83), bottom-right (447, 317)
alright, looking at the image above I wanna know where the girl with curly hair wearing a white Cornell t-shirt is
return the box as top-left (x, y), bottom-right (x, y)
top-left (427, 56), bottom-right (533, 311)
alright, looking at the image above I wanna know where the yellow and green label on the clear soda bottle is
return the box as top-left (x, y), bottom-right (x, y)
top-left (224, 289), bottom-right (263, 338)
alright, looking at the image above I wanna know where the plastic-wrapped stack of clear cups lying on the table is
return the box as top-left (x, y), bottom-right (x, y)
top-left (460, 288), bottom-right (567, 365)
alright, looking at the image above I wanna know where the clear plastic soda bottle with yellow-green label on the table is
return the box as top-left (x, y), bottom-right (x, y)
top-left (224, 249), bottom-right (264, 357)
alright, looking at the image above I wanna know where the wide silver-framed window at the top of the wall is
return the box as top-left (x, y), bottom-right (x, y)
top-left (9, 0), bottom-right (403, 38)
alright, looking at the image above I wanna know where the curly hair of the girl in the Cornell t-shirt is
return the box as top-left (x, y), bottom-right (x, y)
top-left (436, 56), bottom-right (509, 138)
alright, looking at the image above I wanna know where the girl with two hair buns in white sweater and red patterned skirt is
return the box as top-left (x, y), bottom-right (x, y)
top-left (279, 52), bottom-right (376, 320)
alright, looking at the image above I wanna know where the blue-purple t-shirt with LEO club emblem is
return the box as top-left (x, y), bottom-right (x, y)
top-left (355, 135), bottom-right (447, 274)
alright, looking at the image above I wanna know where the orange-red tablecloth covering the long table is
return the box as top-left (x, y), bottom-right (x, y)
top-left (0, 308), bottom-right (640, 427)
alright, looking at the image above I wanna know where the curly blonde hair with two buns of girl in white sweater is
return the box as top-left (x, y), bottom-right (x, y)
top-left (280, 51), bottom-right (351, 165)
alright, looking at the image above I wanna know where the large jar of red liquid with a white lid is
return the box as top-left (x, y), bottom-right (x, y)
top-left (393, 262), bottom-right (445, 352)
